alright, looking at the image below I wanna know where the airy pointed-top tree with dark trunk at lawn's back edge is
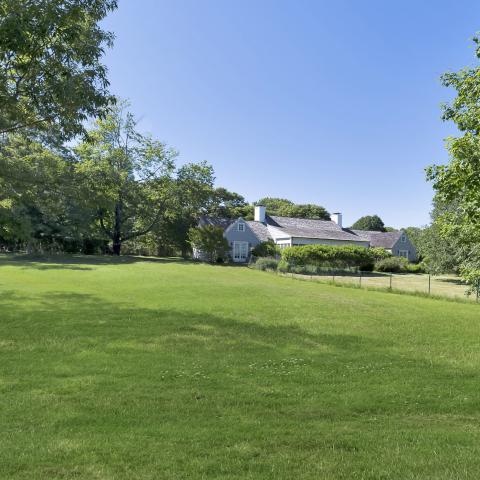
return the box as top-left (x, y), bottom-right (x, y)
top-left (75, 104), bottom-right (176, 255)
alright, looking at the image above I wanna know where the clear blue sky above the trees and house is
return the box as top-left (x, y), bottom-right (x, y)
top-left (100, 0), bottom-right (480, 227)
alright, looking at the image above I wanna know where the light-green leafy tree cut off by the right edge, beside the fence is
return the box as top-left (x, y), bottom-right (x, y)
top-left (427, 33), bottom-right (480, 288)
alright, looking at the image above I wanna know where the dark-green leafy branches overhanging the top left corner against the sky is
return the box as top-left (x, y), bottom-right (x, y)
top-left (0, 0), bottom-right (117, 138)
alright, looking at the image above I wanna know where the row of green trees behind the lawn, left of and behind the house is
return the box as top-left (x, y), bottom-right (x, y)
top-left (0, 103), bottom-right (328, 256)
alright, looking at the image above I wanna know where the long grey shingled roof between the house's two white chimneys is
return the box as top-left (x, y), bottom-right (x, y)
top-left (266, 216), bottom-right (368, 242)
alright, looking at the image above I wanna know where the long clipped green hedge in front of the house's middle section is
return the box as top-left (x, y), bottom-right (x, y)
top-left (282, 245), bottom-right (379, 270)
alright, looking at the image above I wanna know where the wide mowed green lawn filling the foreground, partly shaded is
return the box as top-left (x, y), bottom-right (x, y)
top-left (0, 253), bottom-right (480, 480)
